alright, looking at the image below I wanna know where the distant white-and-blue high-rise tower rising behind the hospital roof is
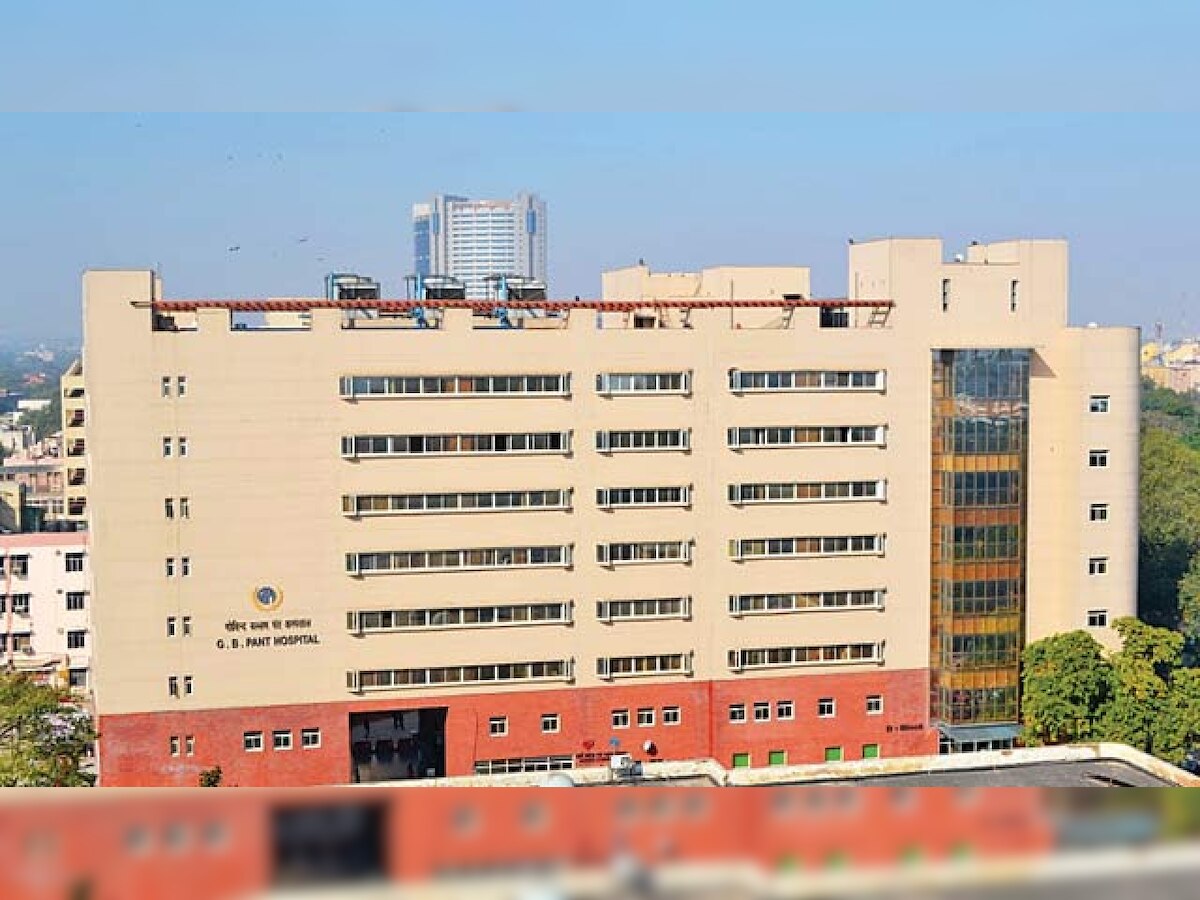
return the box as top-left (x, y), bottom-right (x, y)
top-left (413, 193), bottom-right (546, 298)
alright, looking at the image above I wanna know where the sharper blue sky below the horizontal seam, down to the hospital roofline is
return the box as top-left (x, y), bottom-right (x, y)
top-left (0, 114), bottom-right (1200, 343)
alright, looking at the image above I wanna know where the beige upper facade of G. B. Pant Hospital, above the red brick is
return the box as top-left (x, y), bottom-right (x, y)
top-left (83, 240), bottom-right (1139, 782)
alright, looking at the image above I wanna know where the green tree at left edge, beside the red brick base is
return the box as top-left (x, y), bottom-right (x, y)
top-left (0, 672), bottom-right (96, 787)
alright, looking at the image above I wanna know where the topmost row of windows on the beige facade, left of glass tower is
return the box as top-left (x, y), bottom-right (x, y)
top-left (338, 368), bottom-right (884, 398)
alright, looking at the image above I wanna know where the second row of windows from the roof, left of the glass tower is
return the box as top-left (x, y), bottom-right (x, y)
top-left (333, 425), bottom-right (887, 460)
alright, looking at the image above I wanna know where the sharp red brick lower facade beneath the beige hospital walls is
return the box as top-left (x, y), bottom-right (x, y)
top-left (100, 670), bottom-right (937, 786)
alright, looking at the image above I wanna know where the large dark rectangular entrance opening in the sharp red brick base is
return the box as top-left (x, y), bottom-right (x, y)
top-left (350, 707), bottom-right (446, 784)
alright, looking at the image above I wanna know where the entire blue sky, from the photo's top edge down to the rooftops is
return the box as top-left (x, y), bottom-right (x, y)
top-left (0, 0), bottom-right (1200, 336)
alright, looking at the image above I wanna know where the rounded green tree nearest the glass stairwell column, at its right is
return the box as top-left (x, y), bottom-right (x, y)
top-left (1021, 631), bottom-right (1114, 746)
